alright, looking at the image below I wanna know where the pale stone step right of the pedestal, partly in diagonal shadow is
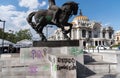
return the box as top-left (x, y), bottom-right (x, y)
top-left (85, 61), bottom-right (116, 74)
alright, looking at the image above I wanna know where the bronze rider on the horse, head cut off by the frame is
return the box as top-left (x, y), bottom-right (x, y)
top-left (48, 0), bottom-right (60, 24)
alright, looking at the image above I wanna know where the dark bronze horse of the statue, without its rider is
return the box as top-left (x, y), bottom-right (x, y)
top-left (27, 1), bottom-right (78, 41)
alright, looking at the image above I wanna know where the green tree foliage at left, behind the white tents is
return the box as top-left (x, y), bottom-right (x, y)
top-left (0, 29), bottom-right (32, 43)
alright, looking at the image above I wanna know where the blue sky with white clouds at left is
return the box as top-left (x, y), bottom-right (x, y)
top-left (0, 0), bottom-right (120, 38)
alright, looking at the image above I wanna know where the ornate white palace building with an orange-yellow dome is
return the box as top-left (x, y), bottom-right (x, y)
top-left (50, 11), bottom-right (114, 47)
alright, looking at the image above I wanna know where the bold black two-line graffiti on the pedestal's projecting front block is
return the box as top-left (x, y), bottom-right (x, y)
top-left (48, 56), bottom-right (76, 71)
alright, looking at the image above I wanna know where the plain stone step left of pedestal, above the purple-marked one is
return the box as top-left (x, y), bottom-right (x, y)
top-left (0, 58), bottom-right (49, 67)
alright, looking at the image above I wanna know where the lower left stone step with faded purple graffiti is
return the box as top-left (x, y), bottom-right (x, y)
top-left (1, 65), bottom-right (51, 76)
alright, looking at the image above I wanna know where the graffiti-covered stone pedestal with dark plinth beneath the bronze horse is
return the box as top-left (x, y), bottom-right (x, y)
top-left (20, 40), bottom-right (84, 78)
